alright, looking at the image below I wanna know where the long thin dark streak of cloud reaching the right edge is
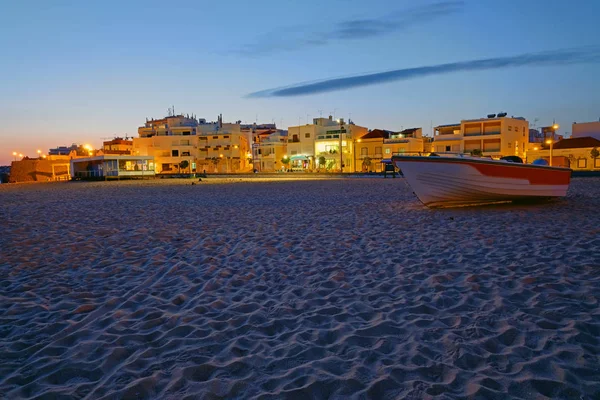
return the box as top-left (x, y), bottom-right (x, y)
top-left (246, 47), bottom-right (600, 97)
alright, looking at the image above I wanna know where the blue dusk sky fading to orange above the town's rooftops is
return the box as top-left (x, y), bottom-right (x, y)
top-left (0, 0), bottom-right (600, 165)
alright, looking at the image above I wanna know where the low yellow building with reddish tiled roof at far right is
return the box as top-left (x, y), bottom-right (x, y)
top-left (526, 137), bottom-right (600, 171)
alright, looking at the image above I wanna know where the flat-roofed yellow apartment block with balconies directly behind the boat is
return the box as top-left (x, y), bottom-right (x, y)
top-left (431, 113), bottom-right (529, 158)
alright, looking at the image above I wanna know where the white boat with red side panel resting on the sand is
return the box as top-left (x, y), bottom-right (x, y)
top-left (392, 155), bottom-right (571, 207)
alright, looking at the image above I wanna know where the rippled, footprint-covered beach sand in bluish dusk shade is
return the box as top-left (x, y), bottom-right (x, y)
top-left (0, 178), bottom-right (600, 399)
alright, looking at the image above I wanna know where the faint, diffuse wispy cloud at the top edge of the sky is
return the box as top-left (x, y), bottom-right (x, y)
top-left (238, 0), bottom-right (464, 57)
